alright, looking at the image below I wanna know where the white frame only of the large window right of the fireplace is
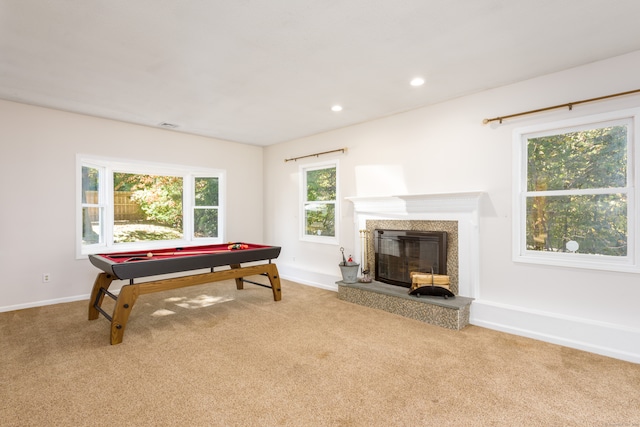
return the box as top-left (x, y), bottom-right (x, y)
top-left (512, 109), bottom-right (640, 273)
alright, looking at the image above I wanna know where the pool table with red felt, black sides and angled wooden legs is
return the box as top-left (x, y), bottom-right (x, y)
top-left (89, 243), bottom-right (282, 344)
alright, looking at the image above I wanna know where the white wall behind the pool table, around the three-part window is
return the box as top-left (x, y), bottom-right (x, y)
top-left (0, 100), bottom-right (265, 311)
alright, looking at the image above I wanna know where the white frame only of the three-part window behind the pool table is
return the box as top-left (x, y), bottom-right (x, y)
top-left (76, 154), bottom-right (226, 259)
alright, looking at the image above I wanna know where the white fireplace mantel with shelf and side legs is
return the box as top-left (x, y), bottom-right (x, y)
top-left (346, 192), bottom-right (485, 298)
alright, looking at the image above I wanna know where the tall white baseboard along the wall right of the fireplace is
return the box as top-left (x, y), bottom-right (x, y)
top-left (470, 300), bottom-right (640, 364)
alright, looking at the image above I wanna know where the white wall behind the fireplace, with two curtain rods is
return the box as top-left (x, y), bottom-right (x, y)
top-left (265, 52), bottom-right (640, 363)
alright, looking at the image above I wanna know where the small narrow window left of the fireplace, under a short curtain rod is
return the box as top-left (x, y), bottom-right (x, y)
top-left (300, 161), bottom-right (338, 244)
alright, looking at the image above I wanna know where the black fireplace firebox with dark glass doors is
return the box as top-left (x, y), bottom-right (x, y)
top-left (373, 229), bottom-right (447, 288)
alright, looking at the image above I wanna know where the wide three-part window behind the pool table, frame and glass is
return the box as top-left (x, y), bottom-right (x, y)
top-left (77, 155), bottom-right (225, 256)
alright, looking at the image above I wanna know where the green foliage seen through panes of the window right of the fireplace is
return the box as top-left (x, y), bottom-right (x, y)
top-left (526, 125), bottom-right (628, 256)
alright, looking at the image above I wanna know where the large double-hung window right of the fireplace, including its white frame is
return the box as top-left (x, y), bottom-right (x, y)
top-left (513, 111), bottom-right (638, 271)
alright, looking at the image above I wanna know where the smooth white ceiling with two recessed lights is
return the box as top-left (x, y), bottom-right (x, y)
top-left (0, 0), bottom-right (640, 146)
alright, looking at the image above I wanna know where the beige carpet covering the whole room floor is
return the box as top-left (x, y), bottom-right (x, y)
top-left (0, 278), bottom-right (640, 427)
